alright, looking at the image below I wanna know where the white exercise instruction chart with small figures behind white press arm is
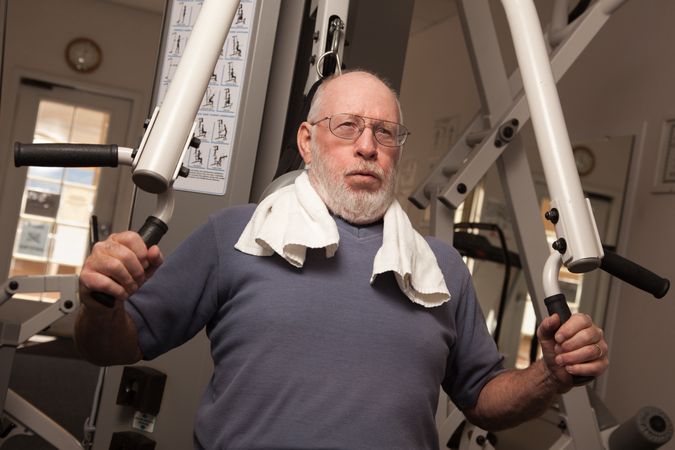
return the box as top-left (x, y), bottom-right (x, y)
top-left (158, 0), bottom-right (256, 195)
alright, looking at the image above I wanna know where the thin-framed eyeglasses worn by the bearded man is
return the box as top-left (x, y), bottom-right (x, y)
top-left (310, 113), bottom-right (410, 147)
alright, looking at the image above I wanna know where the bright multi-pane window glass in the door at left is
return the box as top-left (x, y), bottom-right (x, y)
top-left (10, 100), bottom-right (110, 300)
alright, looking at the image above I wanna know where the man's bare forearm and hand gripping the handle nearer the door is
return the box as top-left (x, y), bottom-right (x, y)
top-left (75, 231), bottom-right (163, 366)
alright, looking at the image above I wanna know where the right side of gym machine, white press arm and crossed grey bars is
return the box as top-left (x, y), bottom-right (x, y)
top-left (410, 0), bottom-right (673, 450)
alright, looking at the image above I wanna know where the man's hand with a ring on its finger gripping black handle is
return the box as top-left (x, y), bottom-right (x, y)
top-left (537, 314), bottom-right (609, 393)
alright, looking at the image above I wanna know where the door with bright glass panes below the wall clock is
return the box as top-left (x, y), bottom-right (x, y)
top-left (0, 80), bottom-right (132, 300)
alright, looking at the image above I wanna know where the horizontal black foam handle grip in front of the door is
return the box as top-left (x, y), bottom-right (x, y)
top-left (14, 142), bottom-right (118, 167)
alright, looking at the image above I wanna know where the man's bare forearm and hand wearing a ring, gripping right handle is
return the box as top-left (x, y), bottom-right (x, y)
top-left (464, 314), bottom-right (609, 430)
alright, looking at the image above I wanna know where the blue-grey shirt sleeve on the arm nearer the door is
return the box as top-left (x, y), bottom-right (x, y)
top-left (125, 218), bottom-right (218, 360)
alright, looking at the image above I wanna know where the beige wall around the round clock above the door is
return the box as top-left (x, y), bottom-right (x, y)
top-left (0, 0), bottom-right (162, 185)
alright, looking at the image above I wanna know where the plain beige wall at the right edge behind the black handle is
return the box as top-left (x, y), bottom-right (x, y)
top-left (561, 0), bottom-right (675, 449)
